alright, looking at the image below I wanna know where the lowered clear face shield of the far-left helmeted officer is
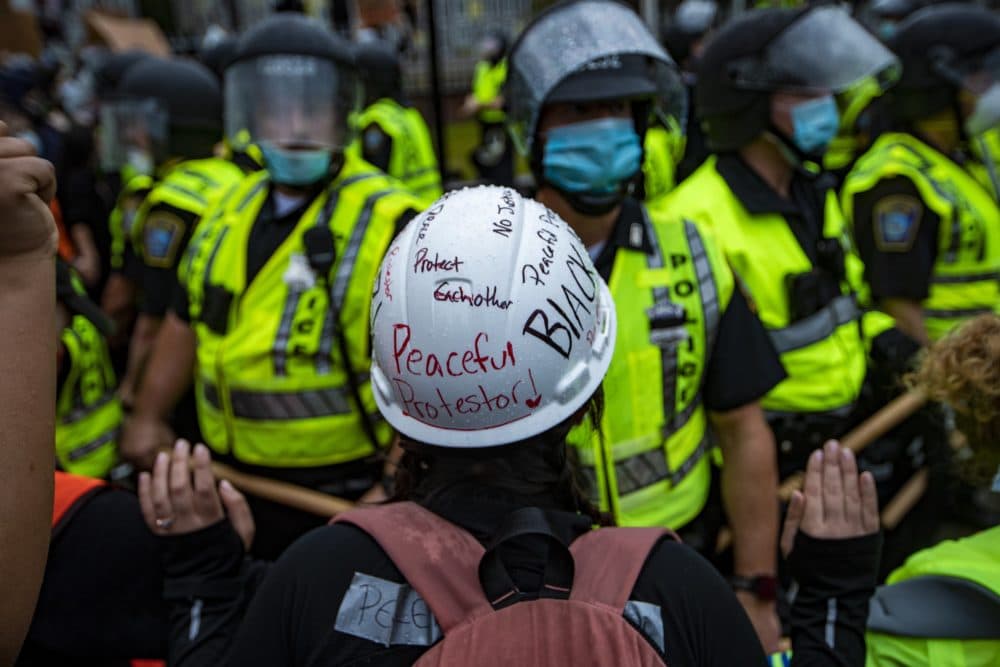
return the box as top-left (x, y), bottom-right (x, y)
top-left (99, 98), bottom-right (170, 175)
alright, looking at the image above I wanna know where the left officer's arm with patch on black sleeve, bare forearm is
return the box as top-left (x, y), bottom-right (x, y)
top-left (120, 203), bottom-right (198, 404)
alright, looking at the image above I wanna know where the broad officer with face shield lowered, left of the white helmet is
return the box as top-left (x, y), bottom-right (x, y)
top-left (124, 13), bottom-right (422, 557)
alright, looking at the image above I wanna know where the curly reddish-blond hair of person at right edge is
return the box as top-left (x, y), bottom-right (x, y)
top-left (914, 315), bottom-right (1000, 483)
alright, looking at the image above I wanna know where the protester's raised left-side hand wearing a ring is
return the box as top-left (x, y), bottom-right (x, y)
top-left (139, 440), bottom-right (256, 548)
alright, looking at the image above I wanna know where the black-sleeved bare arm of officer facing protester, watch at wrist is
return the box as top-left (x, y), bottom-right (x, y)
top-left (703, 289), bottom-right (785, 652)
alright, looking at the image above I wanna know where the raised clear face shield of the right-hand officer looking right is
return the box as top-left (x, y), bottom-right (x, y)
top-left (735, 6), bottom-right (901, 94)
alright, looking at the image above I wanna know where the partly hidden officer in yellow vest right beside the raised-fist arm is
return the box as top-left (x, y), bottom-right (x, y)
top-left (55, 260), bottom-right (122, 478)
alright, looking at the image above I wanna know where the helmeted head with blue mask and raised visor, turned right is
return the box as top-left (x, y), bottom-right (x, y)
top-left (695, 5), bottom-right (899, 163)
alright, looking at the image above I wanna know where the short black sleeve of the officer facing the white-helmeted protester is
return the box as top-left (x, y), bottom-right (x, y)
top-left (702, 289), bottom-right (786, 412)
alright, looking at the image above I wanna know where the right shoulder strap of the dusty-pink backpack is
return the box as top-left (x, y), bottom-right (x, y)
top-left (570, 528), bottom-right (679, 613)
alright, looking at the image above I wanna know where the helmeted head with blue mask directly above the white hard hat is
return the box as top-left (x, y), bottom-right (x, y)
top-left (504, 0), bottom-right (686, 216)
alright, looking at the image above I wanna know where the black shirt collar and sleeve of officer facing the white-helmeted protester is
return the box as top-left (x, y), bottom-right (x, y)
top-left (594, 199), bottom-right (786, 412)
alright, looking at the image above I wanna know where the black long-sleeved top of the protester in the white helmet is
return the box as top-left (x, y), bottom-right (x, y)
top-left (158, 484), bottom-right (881, 667)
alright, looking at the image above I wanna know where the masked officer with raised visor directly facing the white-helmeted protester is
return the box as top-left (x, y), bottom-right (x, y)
top-left (507, 1), bottom-right (784, 648)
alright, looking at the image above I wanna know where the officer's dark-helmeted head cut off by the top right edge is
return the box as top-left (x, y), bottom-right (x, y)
top-left (888, 3), bottom-right (1000, 140)
